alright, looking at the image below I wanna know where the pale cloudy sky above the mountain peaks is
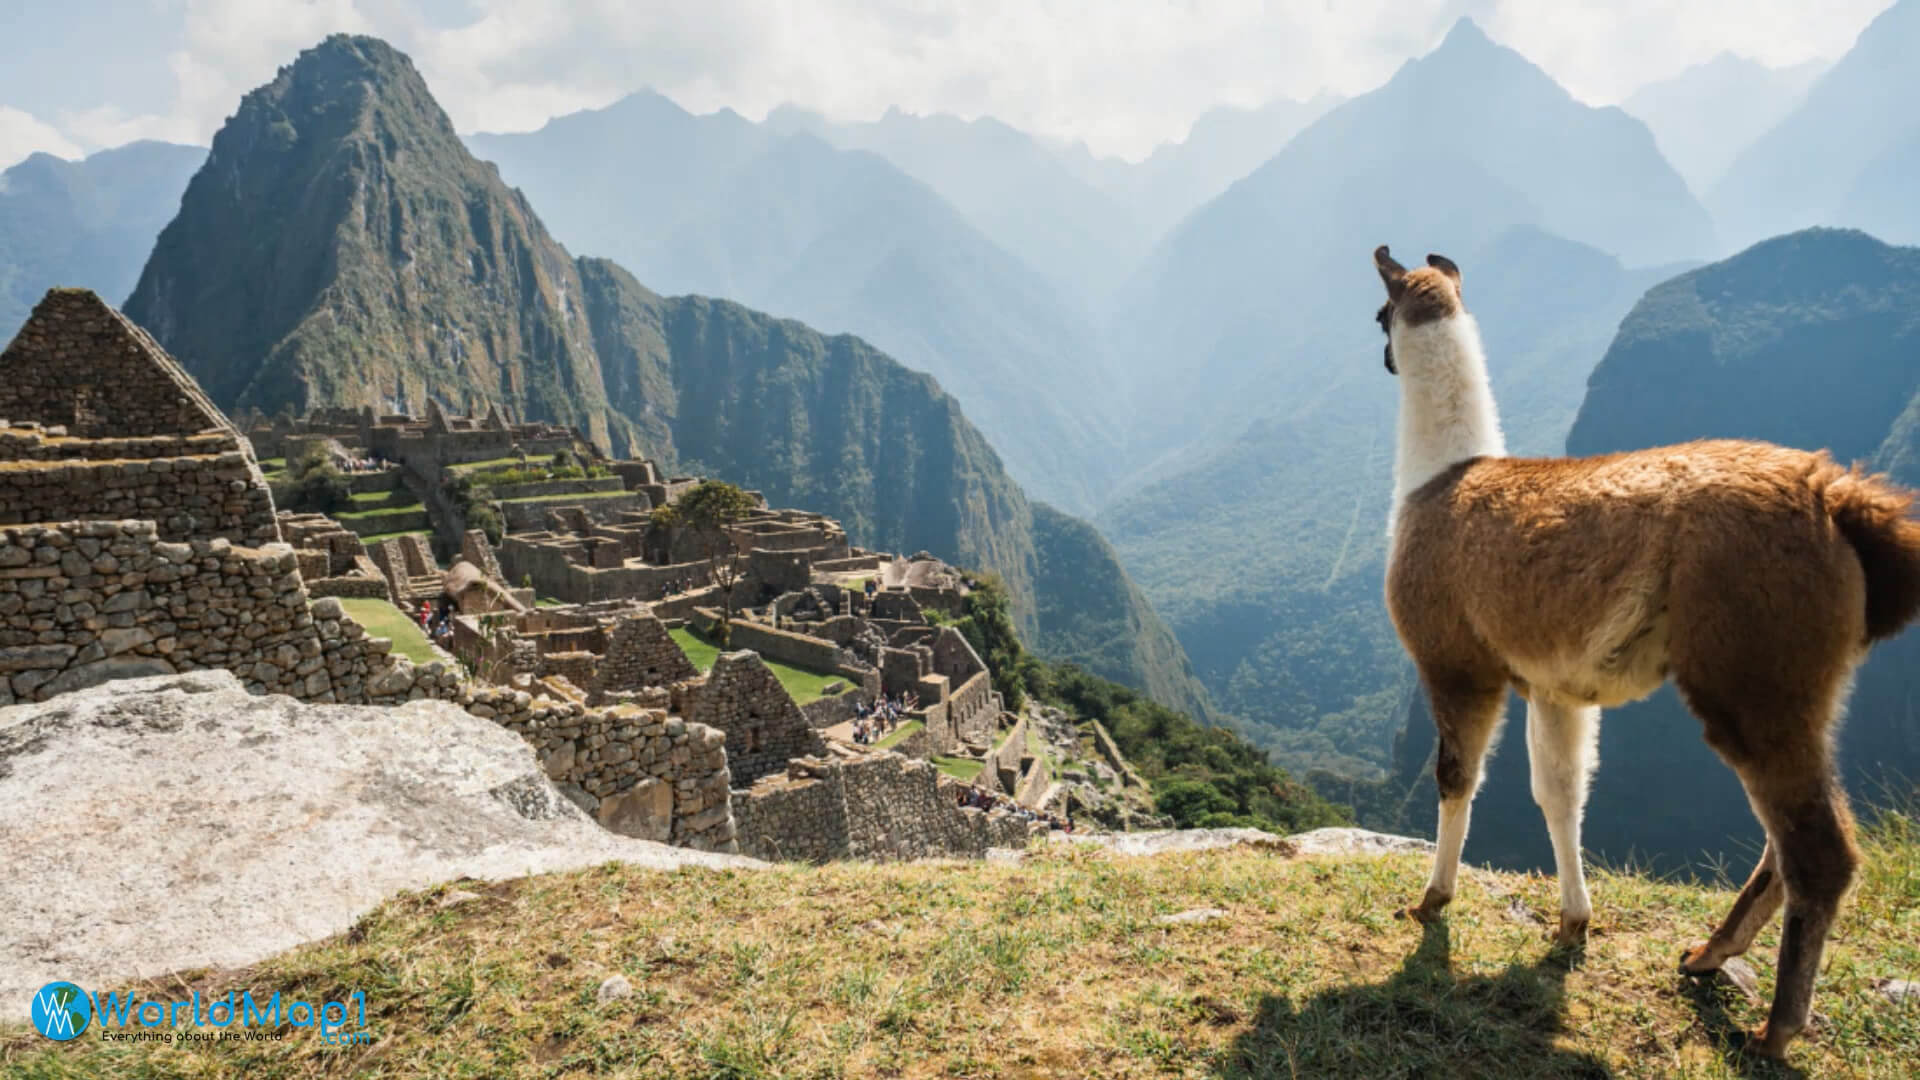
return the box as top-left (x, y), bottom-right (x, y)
top-left (0, 0), bottom-right (1896, 167)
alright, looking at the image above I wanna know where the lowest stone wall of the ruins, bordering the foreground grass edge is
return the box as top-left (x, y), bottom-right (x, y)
top-left (733, 753), bottom-right (1033, 861)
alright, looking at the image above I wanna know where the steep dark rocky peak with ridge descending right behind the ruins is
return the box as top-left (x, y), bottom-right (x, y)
top-left (116, 35), bottom-right (1212, 717)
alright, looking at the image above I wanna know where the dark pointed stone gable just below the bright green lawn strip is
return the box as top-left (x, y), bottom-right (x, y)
top-left (674, 651), bottom-right (826, 784)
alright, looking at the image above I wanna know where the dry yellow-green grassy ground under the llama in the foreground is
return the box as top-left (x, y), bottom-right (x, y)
top-left (0, 819), bottom-right (1920, 1080)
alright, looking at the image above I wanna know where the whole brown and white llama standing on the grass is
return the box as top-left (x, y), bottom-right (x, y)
top-left (1373, 246), bottom-right (1920, 1057)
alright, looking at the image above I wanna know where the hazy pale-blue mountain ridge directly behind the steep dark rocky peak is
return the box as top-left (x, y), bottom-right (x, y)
top-left (468, 94), bottom-right (1119, 511)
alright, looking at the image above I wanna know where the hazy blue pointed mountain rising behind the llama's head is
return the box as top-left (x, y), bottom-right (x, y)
top-left (1114, 19), bottom-right (1713, 461)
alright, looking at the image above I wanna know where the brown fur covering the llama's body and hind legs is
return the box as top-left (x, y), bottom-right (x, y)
top-left (1386, 440), bottom-right (1920, 1053)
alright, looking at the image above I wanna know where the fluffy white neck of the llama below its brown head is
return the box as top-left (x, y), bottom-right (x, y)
top-left (1392, 311), bottom-right (1507, 517)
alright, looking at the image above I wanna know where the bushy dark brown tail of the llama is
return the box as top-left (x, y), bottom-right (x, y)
top-left (1826, 465), bottom-right (1920, 642)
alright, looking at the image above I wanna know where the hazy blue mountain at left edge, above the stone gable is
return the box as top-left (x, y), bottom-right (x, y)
top-left (0, 142), bottom-right (207, 340)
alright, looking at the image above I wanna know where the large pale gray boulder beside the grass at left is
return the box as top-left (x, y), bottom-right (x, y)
top-left (0, 671), bottom-right (762, 1015)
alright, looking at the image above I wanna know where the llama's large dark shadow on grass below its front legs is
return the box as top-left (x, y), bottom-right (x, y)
top-left (1219, 922), bottom-right (1613, 1080)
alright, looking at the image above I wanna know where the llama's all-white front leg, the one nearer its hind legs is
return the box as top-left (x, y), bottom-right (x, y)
top-left (1526, 694), bottom-right (1599, 945)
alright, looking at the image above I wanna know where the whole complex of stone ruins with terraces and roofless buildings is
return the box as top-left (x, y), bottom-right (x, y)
top-left (0, 290), bottom-right (1160, 859)
